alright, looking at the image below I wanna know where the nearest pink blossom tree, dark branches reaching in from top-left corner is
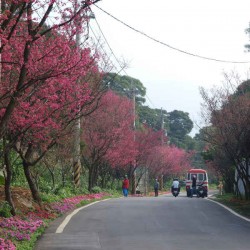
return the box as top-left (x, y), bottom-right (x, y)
top-left (0, 0), bottom-right (99, 137)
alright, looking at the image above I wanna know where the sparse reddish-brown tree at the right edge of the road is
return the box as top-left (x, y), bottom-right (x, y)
top-left (201, 78), bottom-right (250, 199)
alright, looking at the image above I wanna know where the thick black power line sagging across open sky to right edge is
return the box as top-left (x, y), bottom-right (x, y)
top-left (94, 4), bottom-right (250, 63)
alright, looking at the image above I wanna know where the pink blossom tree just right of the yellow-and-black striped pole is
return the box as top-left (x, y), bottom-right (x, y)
top-left (82, 91), bottom-right (135, 190)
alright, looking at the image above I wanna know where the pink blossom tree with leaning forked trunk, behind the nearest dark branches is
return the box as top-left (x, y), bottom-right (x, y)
top-left (0, 21), bottom-right (101, 205)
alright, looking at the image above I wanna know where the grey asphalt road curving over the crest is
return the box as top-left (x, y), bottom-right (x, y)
top-left (35, 195), bottom-right (250, 250)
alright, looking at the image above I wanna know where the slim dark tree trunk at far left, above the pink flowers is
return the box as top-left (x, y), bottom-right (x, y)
top-left (4, 140), bottom-right (16, 215)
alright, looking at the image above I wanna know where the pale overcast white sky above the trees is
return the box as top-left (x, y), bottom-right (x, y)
top-left (90, 0), bottom-right (250, 135)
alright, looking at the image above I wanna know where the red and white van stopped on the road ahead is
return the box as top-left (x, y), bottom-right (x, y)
top-left (186, 168), bottom-right (208, 197)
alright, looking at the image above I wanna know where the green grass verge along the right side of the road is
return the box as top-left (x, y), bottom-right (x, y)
top-left (211, 194), bottom-right (250, 219)
